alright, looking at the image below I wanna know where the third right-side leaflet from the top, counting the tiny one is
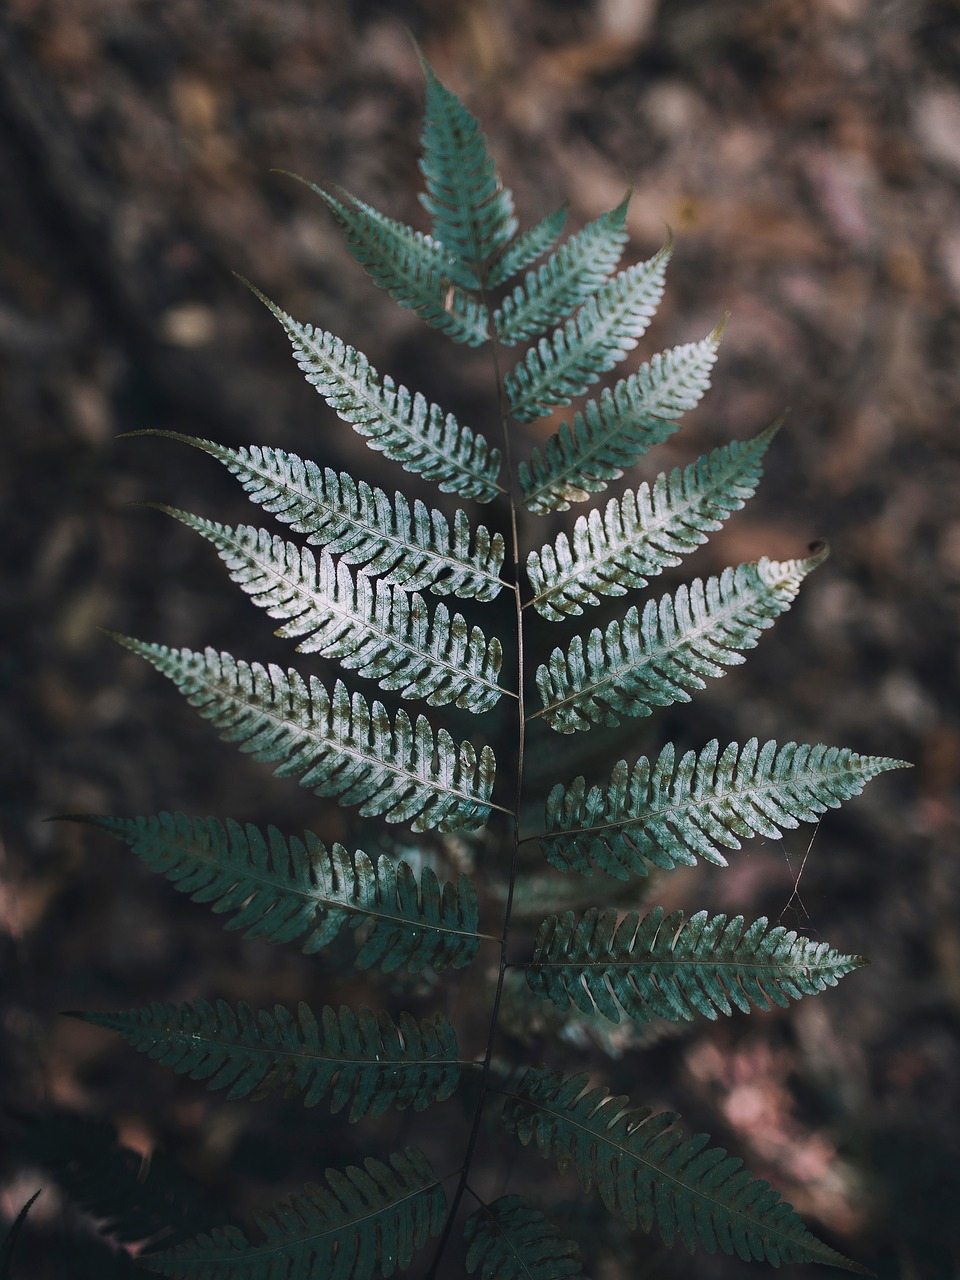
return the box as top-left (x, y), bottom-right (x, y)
top-left (503, 244), bottom-right (671, 422)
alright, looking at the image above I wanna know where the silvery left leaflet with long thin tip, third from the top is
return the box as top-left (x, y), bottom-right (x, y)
top-left (145, 431), bottom-right (504, 600)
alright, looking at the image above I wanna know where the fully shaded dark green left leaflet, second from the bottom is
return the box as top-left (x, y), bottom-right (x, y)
top-left (76, 1000), bottom-right (460, 1120)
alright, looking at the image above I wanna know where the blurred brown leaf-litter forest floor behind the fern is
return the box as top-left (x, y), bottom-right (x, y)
top-left (0, 0), bottom-right (960, 1280)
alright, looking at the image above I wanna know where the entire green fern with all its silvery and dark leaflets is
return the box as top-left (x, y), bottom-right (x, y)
top-left (52, 55), bottom-right (901, 1280)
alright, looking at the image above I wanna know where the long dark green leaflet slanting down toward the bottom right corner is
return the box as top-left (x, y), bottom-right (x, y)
top-left (503, 1069), bottom-right (869, 1275)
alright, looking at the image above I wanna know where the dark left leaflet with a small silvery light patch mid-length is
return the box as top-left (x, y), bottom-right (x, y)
top-left (69, 813), bottom-right (485, 973)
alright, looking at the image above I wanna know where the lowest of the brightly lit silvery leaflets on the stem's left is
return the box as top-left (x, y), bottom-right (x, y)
top-left (114, 635), bottom-right (495, 831)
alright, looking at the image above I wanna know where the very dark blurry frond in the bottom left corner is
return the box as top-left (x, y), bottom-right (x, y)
top-left (17, 1111), bottom-right (232, 1257)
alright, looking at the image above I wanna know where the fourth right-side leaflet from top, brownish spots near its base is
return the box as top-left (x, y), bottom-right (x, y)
top-left (517, 321), bottom-right (726, 515)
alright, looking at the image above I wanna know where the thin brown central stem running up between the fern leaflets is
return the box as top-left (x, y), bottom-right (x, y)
top-left (428, 264), bottom-right (526, 1280)
